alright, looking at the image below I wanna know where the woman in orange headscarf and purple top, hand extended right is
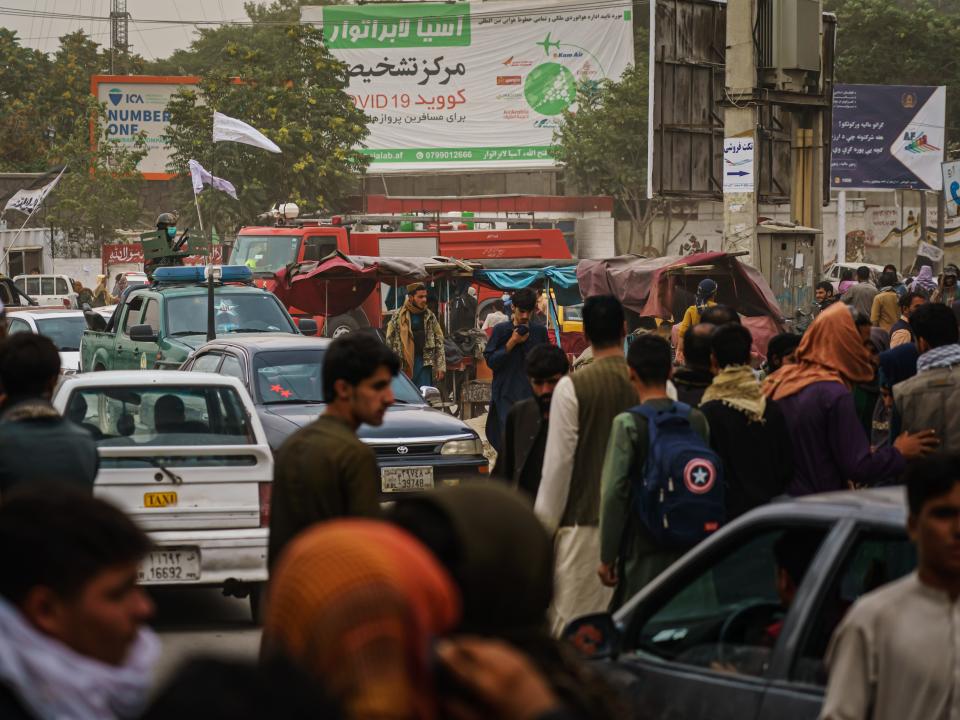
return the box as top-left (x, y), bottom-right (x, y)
top-left (764, 304), bottom-right (930, 496)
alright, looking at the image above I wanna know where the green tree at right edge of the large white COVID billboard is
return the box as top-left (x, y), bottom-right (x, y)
top-left (554, 60), bottom-right (655, 250)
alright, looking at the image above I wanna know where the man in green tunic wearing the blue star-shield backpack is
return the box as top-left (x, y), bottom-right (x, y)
top-left (594, 334), bottom-right (709, 609)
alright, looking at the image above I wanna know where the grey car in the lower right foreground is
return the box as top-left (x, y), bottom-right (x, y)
top-left (564, 488), bottom-right (916, 720)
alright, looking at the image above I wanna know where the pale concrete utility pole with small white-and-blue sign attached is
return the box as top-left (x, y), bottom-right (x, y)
top-left (722, 0), bottom-right (760, 269)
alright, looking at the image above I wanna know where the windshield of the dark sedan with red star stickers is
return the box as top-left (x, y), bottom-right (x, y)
top-left (253, 349), bottom-right (424, 405)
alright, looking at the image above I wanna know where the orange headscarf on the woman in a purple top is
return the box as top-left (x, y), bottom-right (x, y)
top-left (763, 303), bottom-right (874, 400)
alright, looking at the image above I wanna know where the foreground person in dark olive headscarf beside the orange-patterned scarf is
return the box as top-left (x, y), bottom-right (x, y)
top-left (389, 483), bottom-right (622, 720)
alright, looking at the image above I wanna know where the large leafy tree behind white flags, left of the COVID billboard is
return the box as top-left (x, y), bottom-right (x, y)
top-left (167, 0), bottom-right (367, 230)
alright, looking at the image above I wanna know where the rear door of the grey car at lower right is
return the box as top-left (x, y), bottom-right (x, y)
top-left (759, 523), bottom-right (917, 720)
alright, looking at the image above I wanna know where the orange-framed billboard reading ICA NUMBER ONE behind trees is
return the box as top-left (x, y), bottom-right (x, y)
top-left (90, 75), bottom-right (199, 180)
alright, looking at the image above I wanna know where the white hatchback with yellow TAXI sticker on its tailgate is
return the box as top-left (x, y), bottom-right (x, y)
top-left (53, 370), bottom-right (273, 617)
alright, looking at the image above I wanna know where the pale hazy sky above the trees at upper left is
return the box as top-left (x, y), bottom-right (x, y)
top-left (0, 0), bottom-right (265, 60)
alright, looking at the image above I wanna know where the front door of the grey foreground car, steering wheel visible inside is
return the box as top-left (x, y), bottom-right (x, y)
top-left (619, 519), bottom-right (831, 720)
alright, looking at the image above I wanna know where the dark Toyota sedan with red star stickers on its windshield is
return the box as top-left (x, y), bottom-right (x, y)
top-left (182, 334), bottom-right (488, 500)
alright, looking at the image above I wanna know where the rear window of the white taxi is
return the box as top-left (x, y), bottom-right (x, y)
top-left (64, 385), bottom-right (254, 447)
